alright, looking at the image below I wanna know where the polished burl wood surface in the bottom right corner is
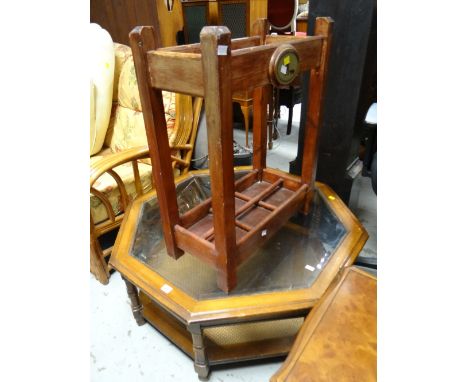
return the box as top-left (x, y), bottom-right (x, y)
top-left (270, 268), bottom-right (377, 382)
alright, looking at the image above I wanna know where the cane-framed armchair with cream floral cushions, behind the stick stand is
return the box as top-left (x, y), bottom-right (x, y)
top-left (90, 43), bottom-right (202, 284)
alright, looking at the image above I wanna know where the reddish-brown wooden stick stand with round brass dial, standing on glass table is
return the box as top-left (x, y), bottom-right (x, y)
top-left (130, 18), bottom-right (333, 292)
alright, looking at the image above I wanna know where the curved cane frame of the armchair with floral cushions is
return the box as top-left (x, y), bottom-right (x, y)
top-left (90, 94), bottom-right (203, 284)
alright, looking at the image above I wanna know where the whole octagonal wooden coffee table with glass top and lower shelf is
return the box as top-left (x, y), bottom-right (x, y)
top-left (110, 168), bottom-right (368, 378)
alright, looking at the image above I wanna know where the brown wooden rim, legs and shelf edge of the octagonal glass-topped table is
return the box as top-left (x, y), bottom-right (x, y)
top-left (110, 170), bottom-right (368, 377)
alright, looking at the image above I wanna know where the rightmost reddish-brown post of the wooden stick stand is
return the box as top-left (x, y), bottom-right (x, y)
top-left (301, 17), bottom-right (333, 213)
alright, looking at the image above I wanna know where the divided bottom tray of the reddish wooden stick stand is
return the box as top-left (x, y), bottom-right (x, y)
top-left (175, 169), bottom-right (309, 266)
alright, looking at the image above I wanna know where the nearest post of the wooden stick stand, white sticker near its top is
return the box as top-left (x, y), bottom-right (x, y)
top-left (200, 26), bottom-right (236, 292)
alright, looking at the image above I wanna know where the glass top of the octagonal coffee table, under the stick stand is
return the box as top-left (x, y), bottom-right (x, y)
top-left (130, 171), bottom-right (347, 300)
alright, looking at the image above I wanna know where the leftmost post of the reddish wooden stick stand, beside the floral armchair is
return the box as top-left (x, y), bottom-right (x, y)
top-left (129, 27), bottom-right (183, 259)
